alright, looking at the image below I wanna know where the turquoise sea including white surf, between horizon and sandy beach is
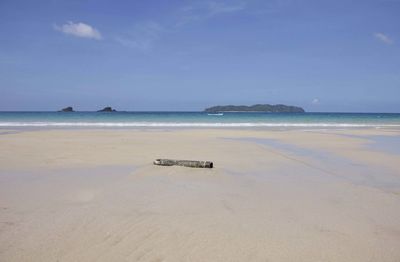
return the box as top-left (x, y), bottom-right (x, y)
top-left (0, 112), bottom-right (400, 127)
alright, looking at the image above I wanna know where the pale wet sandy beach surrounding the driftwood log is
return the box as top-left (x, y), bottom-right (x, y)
top-left (0, 128), bottom-right (400, 262)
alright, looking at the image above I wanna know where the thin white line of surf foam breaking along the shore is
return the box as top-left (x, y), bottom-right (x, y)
top-left (0, 122), bottom-right (400, 128)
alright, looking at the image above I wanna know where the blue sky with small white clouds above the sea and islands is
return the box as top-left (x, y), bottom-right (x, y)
top-left (0, 0), bottom-right (400, 112)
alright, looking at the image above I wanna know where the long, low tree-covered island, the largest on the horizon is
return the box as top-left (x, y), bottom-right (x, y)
top-left (204, 104), bottom-right (305, 113)
